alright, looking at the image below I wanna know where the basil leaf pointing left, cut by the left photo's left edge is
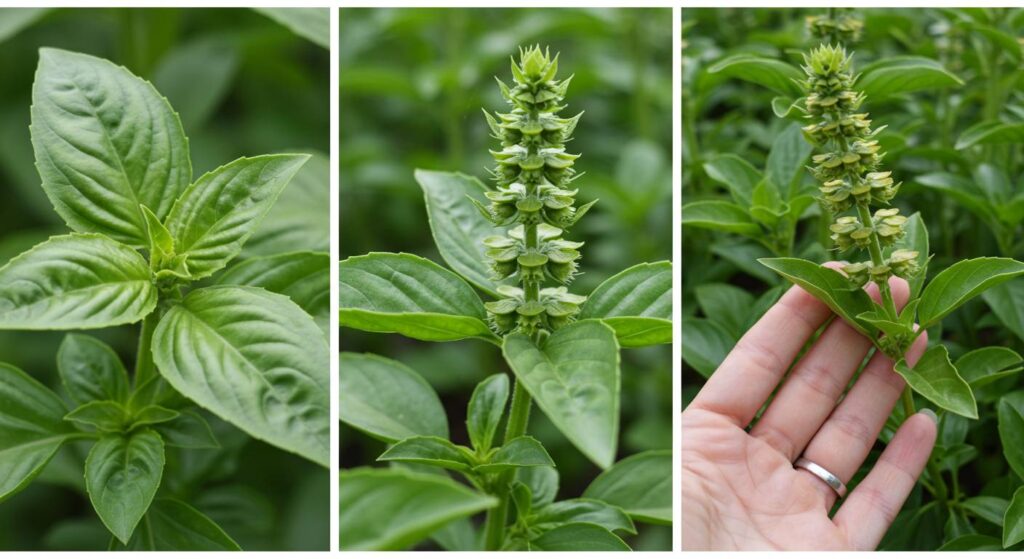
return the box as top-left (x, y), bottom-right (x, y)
top-left (0, 233), bottom-right (157, 330)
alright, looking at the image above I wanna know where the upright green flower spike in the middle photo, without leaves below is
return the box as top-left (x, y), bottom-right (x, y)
top-left (478, 46), bottom-right (593, 340)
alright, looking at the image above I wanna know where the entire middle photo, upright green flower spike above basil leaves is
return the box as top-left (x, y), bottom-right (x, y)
top-left (339, 9), bottom-right (672, 551)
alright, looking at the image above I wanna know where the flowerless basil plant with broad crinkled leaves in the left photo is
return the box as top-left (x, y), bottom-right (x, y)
top-left (0, 48), bottom-right (330, 550)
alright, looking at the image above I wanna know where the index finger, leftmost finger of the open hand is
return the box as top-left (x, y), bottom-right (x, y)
top-left (684, 286), bottom-right (831, 428)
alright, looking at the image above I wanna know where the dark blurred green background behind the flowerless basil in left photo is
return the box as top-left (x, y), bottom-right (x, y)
top-left (0, 8), bottom-right (330, 550)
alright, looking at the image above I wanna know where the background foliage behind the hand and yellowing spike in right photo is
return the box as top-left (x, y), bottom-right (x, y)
top-left (682, 8), bottom-right (1024, 550)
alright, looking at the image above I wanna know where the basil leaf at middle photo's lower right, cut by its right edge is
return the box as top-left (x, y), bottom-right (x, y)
top-left (583, 450), bottom-right (672, 524)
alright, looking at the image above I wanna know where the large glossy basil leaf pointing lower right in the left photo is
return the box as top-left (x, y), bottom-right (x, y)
top-left (153, 286), bottom-right (331, 466)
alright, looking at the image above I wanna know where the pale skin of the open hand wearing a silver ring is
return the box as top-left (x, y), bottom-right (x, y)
top-left (682, 272), bottom-right (937, 550)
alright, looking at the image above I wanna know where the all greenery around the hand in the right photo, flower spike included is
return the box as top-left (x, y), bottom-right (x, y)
top-left (682, 8), bottom-right (1024, 550)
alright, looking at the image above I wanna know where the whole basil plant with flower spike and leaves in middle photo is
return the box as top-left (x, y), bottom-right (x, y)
top-left (339, 47), bottom-right (672, 550)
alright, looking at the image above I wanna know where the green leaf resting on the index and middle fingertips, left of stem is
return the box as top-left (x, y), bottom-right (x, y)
top-left (758, 258), bottom-right (874, 338)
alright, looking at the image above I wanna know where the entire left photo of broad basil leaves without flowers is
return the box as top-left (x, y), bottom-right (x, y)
top-left (0, 8), bottom-right (330, 551)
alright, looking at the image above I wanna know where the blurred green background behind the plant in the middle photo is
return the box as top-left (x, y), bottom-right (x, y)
top-left (339, 8), bottom-right (672, 550)
